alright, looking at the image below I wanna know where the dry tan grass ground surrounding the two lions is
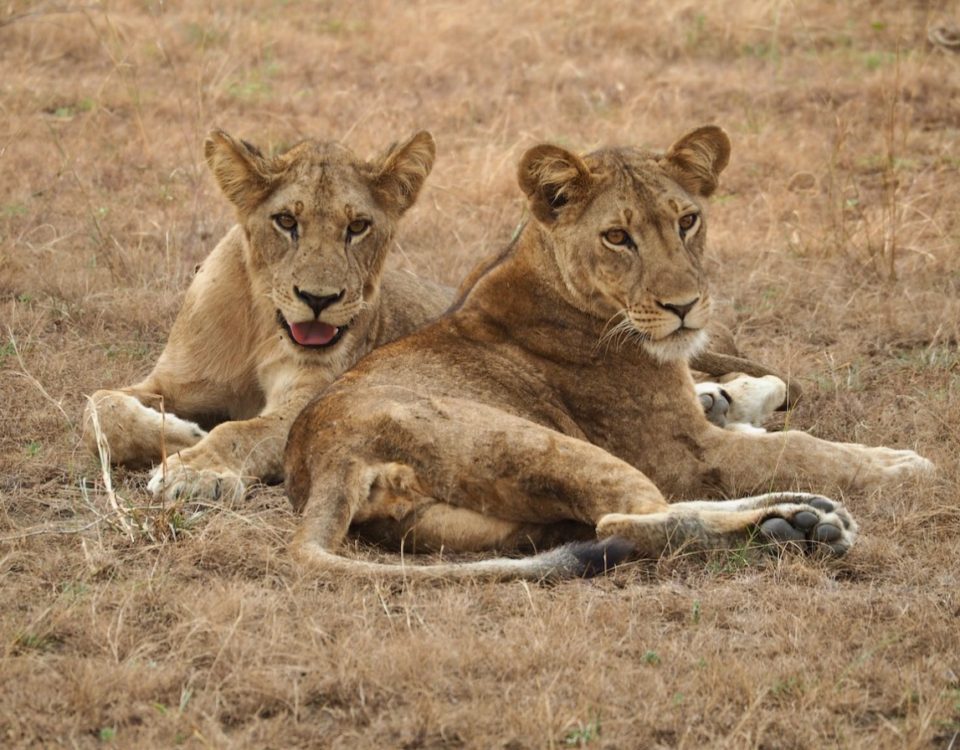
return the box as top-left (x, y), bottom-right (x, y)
top-left (0, 0), bottom-right (960, 748)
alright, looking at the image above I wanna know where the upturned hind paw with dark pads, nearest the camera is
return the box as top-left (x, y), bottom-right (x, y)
top-left (760, 494), bottom-right (857, 557)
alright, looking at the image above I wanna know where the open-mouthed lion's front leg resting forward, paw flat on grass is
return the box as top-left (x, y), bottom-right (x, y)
top-left (147, 390), bottom-right (314, 500)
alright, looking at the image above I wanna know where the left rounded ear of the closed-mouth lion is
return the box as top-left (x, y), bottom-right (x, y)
top-left (517, 144), bottom-right (592, 224)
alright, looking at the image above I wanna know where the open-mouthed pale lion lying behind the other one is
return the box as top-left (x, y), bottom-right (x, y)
top-left (85, 131), bottom-right (444, 497)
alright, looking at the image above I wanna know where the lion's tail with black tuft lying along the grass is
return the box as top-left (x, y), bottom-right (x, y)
top-left (293, 536), bottom-right (634, 581)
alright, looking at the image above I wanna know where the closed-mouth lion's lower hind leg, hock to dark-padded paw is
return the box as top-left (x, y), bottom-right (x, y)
top-left (597, 492), bottom-right (857, 557)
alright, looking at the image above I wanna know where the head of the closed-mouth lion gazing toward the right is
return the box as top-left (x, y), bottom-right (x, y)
top-left (519, 126), bottom-right (730, 361)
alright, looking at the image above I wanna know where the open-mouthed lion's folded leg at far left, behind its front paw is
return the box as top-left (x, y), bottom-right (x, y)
top-left (83, 389), bottom-right (207, 467)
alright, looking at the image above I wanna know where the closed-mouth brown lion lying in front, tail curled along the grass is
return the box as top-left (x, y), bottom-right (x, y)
top-left (286, 126), bottom-right (932, 579)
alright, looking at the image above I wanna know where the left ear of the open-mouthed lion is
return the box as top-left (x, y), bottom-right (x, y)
top-left (203, 130), bottom-right (273, 213)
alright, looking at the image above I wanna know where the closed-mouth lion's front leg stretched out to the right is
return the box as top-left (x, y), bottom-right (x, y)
top-left (701, 427), bottom-right (934, 494)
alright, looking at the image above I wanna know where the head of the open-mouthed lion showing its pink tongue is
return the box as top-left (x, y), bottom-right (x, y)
top-left (204, 131), bottom-right (436, 356)
